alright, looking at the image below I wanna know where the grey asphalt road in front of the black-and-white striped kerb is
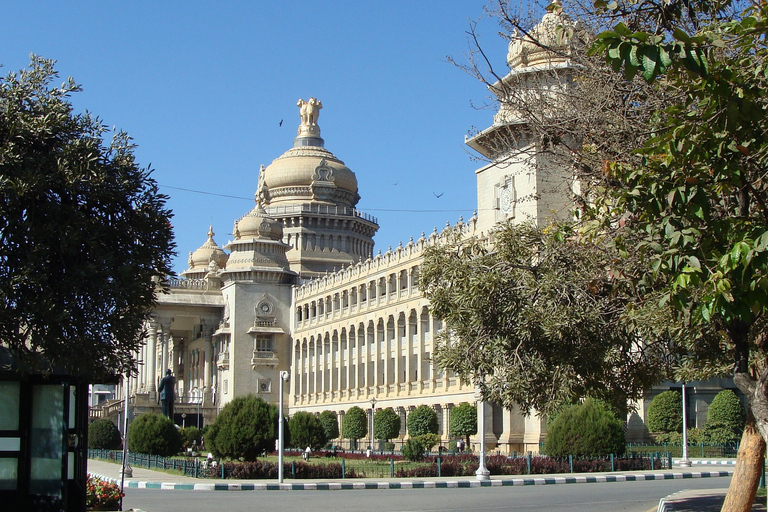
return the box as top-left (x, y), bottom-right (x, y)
top-left (123, 477), bottom-right (730, 512)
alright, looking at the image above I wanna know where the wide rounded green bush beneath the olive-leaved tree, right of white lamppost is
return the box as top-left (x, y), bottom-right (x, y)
top-left (544, 398), bottom-right (625, 457)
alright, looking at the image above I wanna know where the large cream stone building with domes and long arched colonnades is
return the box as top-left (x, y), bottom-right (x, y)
top-left (103, 6), bottom-right (732, 451)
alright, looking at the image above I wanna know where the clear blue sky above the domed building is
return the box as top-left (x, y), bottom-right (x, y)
top-left (0, 0), bottom-right (506, 272)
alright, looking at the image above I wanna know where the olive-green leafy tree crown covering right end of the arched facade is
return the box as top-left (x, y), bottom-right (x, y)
top-left (420, 223), bottom-right (676, 414)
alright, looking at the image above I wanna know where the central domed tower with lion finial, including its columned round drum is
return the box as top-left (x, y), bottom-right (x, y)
top-left (256, 98), bottom-right (379, 278)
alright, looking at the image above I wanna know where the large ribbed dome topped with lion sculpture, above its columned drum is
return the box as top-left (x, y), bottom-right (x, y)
top-left (257, 98), bottom-right (360, 208)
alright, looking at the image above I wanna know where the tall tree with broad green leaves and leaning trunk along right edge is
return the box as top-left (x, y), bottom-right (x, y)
top-left (594, 2), bottom-right (768, 511)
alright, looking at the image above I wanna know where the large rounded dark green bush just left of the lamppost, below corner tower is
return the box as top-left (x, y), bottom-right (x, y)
top-left (205, 395), bottom-right (278, 461)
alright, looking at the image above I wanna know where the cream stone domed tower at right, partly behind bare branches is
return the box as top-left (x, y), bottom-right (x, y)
top-left (466, 0), bottom-right (583, 232)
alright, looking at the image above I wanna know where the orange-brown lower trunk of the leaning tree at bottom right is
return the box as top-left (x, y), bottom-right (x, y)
top-left (720, 420), bottom-right (765, 512)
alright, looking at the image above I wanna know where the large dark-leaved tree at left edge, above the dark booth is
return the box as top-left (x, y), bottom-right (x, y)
top-left (0, 56), bottom-right (174, 377)
